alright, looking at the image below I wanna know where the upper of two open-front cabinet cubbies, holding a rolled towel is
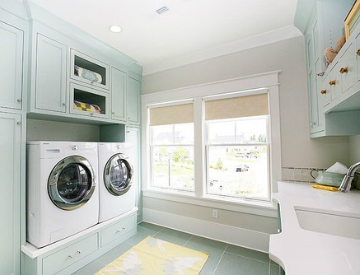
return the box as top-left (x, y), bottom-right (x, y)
top-left (70, 49), bottom-right (110, 90)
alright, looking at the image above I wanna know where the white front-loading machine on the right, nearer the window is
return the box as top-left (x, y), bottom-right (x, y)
top-left (99, 143), bottom-right (136, 222)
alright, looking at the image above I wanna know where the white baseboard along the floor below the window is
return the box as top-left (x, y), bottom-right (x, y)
top-left (143, 208), bottom-right (270, 253)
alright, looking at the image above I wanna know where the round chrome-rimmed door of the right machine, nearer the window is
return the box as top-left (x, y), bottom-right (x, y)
top-left (104, 154), bottom-right (134, 196)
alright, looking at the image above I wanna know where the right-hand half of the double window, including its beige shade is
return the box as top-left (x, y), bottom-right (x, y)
top-left (205, 94), bottom-right (270, 200)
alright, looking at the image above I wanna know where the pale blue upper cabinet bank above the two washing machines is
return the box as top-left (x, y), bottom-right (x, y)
top-left (28, 21), bottom-right (141, 125)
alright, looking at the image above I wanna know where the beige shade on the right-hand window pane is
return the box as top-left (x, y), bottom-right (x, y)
top-left (205, 93), bottom-right (269, 120)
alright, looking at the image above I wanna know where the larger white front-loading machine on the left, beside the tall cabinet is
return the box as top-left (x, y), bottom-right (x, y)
top-left (26, 141), bottom-right (99, 248)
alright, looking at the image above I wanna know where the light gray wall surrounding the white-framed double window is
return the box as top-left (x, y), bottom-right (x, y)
top-left (143, 37), bottom-right (349, 235)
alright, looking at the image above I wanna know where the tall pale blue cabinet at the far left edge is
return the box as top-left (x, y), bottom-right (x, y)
top-left (0, 8), bottom-right (28, 275)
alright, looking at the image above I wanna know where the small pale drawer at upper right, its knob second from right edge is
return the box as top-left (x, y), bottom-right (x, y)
top-left (337, 43), bottom-right (357, 93)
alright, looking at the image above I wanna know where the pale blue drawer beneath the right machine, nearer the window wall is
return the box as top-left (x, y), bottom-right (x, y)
top-left (101, 215), bottom-right (136, 247)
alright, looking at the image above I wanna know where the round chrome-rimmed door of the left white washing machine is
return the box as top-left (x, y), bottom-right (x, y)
top-left (48, 156), bottom-right (95, 210)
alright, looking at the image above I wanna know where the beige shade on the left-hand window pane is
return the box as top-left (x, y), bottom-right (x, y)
top-left (150, 103), bottom-right (194, 126)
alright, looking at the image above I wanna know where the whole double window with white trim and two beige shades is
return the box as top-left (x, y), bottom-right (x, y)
top-left (142, 71), bottom-right (281, 210)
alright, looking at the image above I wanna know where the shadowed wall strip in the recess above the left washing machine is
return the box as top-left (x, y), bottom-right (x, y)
top-left (26, 119), bottom-right (99, 142)
